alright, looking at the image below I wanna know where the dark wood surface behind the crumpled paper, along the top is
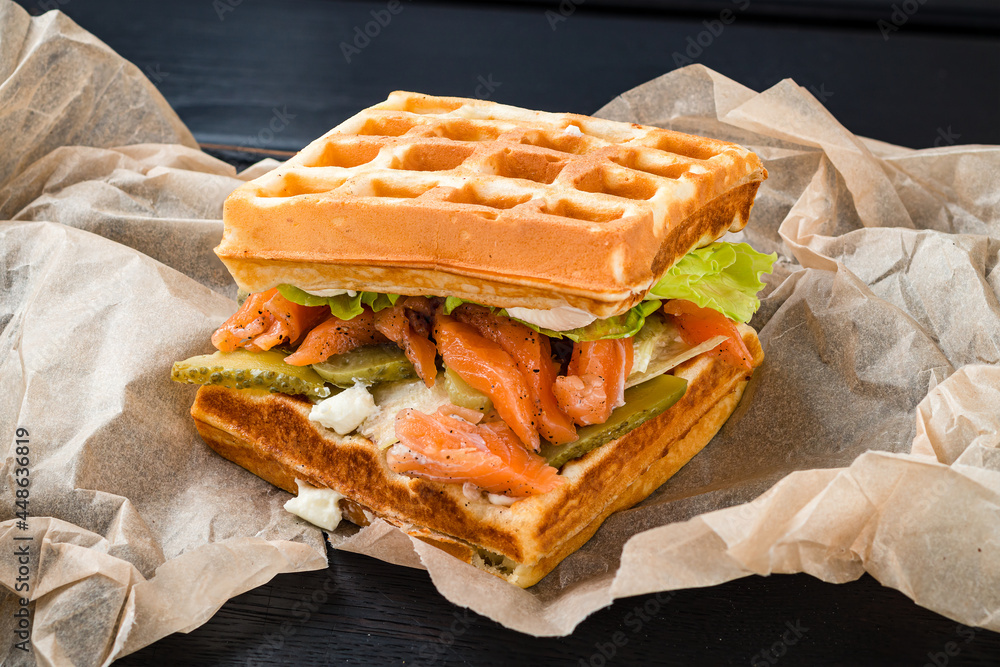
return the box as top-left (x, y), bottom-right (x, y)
top-left (17, 0), bottom-right (1000, 150)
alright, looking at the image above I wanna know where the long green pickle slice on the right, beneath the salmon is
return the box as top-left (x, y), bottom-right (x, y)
top-left (541, 375), bottom-right (687, 468)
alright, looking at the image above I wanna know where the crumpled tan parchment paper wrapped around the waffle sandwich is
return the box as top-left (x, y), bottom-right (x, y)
top-left (0, 2), bottom-right (1000, 665)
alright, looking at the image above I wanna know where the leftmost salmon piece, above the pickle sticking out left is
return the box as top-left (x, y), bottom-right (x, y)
top-left (212, 287), bottom-right (330, 352)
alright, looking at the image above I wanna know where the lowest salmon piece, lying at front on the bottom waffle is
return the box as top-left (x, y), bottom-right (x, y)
top-left (386, 405), bottom-right (563, 498)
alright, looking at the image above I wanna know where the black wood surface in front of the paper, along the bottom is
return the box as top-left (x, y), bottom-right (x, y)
top-left (116, 551), bottom-right (1000, 667)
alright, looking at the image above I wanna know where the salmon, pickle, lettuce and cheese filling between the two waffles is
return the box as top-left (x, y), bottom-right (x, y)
top-left (173, 242), bottom-right (775, 504)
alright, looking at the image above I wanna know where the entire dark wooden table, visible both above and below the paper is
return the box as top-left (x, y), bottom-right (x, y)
top-left (15, 0), bottom-right (1000, 667)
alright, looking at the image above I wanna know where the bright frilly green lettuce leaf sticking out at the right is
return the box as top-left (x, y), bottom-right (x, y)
top-left (646, 242), bottom-right (778, 322)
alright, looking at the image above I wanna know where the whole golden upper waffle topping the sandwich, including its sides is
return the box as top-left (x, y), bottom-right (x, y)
top-left (216, 92), bottom-right (767, 317)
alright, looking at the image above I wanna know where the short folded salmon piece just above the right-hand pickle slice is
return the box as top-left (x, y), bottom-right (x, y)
top-left (552, 338), bottom-right (633, 426)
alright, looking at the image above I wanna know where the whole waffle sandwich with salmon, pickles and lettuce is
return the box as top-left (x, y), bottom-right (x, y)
top-left (173, 92), bottom-right (773, 587)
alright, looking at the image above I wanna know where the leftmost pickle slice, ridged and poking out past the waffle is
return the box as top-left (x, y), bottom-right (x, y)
top-left (170, 350), bottom-right (331, 398)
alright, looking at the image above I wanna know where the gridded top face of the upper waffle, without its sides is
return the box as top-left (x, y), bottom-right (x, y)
top-left (248, 93), bottom-right (747, 232)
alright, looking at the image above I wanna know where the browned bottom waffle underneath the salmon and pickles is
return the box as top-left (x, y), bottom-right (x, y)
top-left (191, 326), bottom-right (763, 587)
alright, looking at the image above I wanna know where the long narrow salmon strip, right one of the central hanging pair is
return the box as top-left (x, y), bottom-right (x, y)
top-left (453, 304), bottom-right (579, 445)
